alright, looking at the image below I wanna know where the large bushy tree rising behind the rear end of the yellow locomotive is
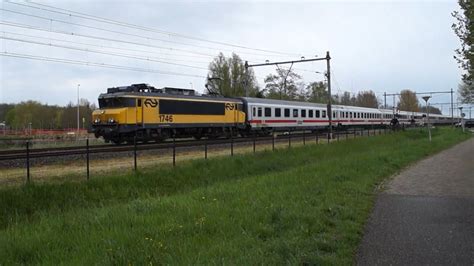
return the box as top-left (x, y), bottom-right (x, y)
top-left (206, 53), bottom-right (261, 97)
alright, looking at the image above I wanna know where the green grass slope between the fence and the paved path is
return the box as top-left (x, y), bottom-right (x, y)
top-left (0, 128), bottom-right (471, 265)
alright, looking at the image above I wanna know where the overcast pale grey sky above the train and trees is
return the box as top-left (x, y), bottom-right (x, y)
top-left (0, 0), bottom-right (461, 113)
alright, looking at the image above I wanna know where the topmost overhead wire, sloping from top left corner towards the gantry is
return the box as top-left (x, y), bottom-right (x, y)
top-left (5, 0), bottom-right (301, 56)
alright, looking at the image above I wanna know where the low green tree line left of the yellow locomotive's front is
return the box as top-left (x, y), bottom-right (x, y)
top-left (0, 99), bottom-right (96, 130)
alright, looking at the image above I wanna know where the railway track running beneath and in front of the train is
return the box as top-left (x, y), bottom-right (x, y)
top-left (0, 132), bottom-right (344, 161)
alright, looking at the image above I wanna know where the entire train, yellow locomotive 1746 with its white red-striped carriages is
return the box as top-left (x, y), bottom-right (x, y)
top-left (90, 84), bottom-right (457, 144)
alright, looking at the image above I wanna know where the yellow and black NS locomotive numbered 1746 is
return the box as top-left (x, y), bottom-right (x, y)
top-left (90, 84), bottom-right (246, 144)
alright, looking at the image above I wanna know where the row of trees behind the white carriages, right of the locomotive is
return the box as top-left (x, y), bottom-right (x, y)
top-left (206, 53), bottom-right (441, 114)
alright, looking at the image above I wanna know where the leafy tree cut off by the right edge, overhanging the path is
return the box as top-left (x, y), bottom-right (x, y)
top-left (452, 0), bottom-right (474, 103)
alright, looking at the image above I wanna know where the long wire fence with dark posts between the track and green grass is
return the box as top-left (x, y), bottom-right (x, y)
top-left (0, 127), bottom-right (391, 185)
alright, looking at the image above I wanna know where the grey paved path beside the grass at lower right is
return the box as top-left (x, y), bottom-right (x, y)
top-left (357, 138), bottom-right (474, 265)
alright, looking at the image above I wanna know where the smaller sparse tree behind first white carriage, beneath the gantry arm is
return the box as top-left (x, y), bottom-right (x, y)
top-left (265, 68), bottom-right (301, 100)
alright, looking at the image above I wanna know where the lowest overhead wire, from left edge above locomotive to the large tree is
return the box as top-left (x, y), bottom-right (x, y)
top-left (0, 52), bottom-right (206, 78)
